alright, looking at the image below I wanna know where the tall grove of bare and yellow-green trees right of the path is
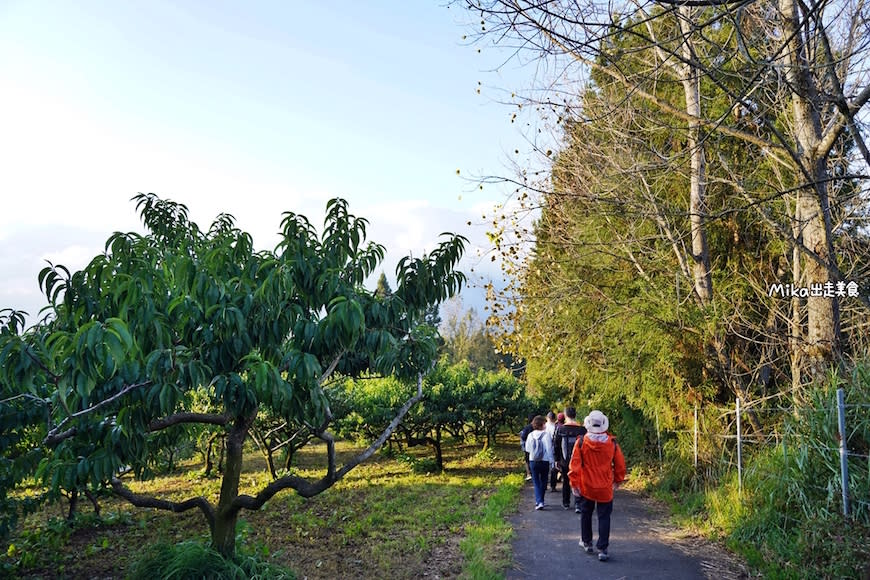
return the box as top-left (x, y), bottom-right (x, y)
top-left (466, 0), bottom-right (870, 427)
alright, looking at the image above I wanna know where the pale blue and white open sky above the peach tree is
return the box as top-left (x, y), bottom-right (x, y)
top-left (0, 0), bottom-right (531, 322)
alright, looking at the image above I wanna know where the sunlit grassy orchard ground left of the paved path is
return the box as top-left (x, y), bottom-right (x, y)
top-left (0, 438), bottom-right (522, 579)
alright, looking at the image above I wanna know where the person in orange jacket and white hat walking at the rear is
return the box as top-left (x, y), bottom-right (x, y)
top-left (568, 411), bottom-right (625, 562)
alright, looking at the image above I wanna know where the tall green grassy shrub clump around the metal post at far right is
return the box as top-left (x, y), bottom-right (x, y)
top-left (706, 366), bottom-right (870, 578)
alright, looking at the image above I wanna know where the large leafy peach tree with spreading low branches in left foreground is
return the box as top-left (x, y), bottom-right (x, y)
top-left (0, 194), bottom-right (466, 556)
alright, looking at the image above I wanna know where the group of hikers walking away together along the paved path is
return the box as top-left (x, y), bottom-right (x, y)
top-left (520, 407), bottom-right (625, 562)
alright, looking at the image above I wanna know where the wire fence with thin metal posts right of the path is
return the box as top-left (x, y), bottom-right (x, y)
top-left (656, 389), bottom-right (870, 521)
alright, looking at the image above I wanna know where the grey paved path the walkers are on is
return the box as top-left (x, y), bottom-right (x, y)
top-left (506, 482), bottom-right (749, 580)
